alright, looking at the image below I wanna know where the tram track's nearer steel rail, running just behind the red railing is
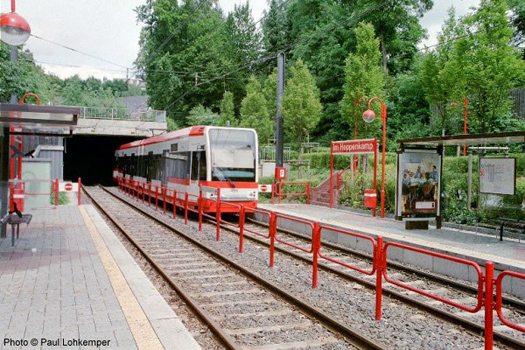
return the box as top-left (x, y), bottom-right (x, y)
top-left (216, 217), bottom-right (525, 350)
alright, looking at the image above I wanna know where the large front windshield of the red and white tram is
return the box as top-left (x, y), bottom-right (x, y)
top-left (209, 129), bottom-right (257, 182)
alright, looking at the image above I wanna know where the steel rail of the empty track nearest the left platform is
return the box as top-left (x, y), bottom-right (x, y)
top-left (82, 185), bottom-right (238, 350)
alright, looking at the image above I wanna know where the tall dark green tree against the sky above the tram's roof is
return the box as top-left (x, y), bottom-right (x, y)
top-left (135, 0), bottom-right (231, 125)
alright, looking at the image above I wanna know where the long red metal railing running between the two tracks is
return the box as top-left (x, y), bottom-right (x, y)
top-left (114, 179), bottom-right (525, 349)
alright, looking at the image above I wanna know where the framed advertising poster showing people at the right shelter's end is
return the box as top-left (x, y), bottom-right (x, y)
top-left (396, 150), bottom-right (441, 218)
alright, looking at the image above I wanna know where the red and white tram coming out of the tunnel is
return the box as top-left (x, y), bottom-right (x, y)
top-left (113, 126), bottom-right (259, 212)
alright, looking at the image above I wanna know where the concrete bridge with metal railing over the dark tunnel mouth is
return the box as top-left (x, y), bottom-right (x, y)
top-left (23, 107), bottom-right (167, 185)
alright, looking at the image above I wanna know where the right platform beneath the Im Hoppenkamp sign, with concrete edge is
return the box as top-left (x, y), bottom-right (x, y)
top-left (256, 204), bottom-right (525, 298)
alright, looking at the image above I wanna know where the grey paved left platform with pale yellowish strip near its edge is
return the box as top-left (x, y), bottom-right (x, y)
top-left (0, 201), bottom-right (201, 349)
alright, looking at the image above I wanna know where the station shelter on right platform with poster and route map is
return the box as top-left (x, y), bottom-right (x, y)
top-left (395, 131), bottom-right (525, 229)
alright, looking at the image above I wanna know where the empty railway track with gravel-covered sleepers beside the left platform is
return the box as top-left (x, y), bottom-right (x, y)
top-left (84, 188), bottom-right (385, 350)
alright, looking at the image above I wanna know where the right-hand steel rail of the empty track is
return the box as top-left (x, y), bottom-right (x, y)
top-left (91, 186), bottom-right (387, 349)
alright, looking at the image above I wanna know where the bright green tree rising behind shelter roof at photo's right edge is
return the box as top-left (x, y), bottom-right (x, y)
top-left (440, 0), bottom-right (525, 133)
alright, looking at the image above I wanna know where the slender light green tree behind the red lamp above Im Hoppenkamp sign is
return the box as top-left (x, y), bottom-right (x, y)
top-left (340, 22), bottom-right (385, 138)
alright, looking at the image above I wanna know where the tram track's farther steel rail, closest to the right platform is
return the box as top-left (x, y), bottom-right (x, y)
top-left (246, 217), bottom-right (525, 314)
